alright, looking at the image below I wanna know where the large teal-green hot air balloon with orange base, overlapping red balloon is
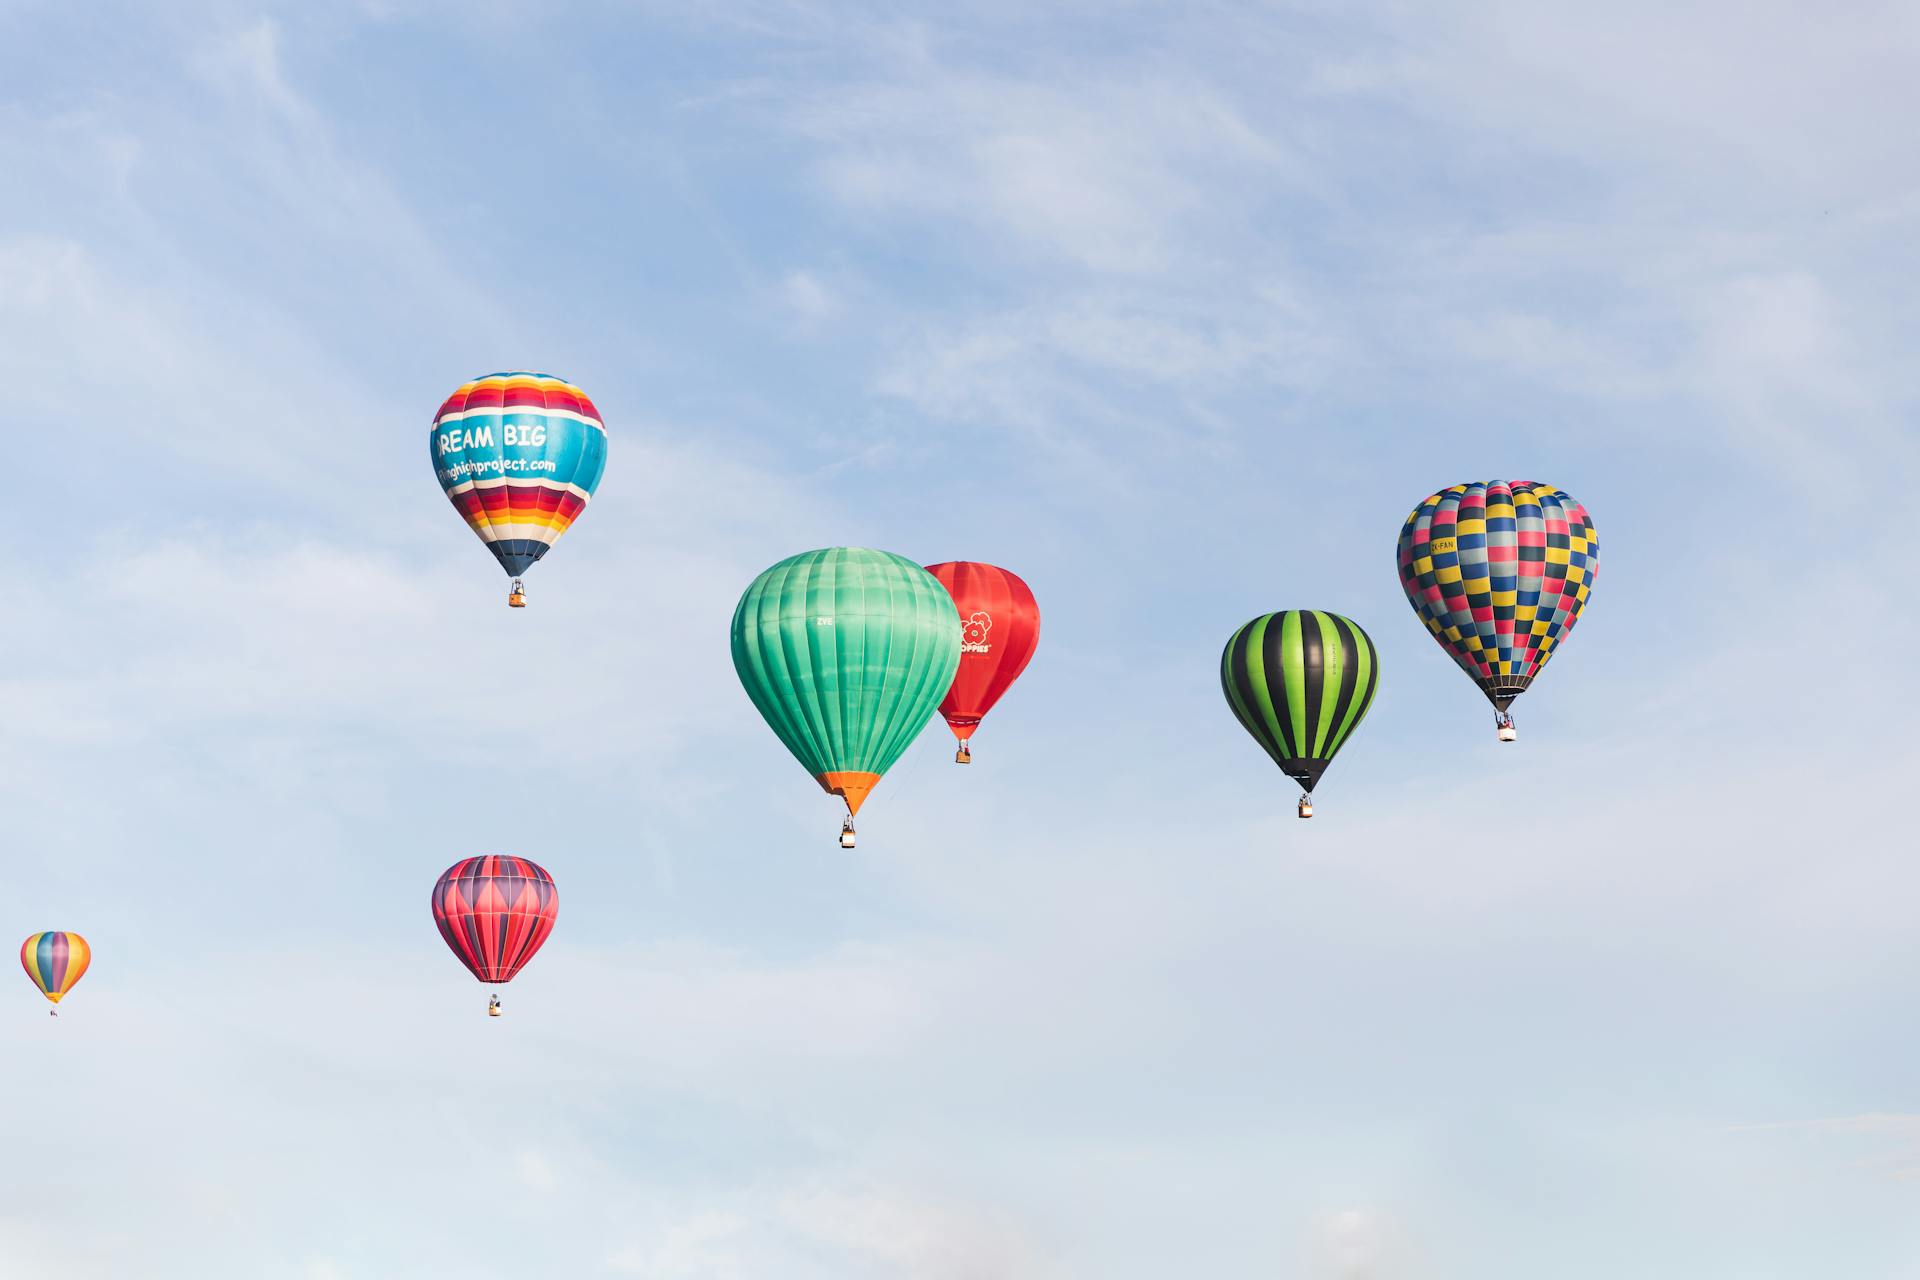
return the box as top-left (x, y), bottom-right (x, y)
top-left (733, 547), bottom-right (960, 848)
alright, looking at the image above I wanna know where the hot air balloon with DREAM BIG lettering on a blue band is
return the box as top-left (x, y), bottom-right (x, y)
top-left (426, 372), bottom-right (607, 608)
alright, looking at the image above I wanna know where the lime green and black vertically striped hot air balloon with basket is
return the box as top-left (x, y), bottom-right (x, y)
top-left (1219, 608), bottom-right (1380, 818)
